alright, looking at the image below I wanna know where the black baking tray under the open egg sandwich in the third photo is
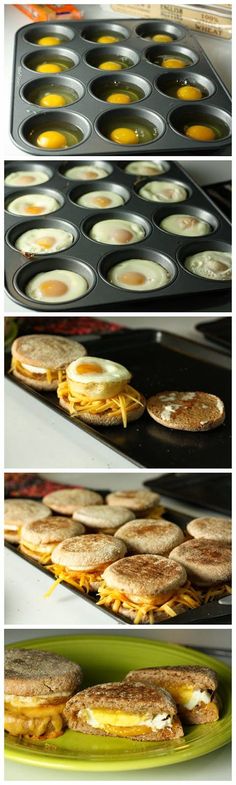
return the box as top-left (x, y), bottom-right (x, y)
top-left (6, 329), bottom-right (231, 470)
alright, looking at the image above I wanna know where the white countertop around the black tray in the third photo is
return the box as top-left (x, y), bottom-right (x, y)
top-left (5, 316), bottom-right (221, 471)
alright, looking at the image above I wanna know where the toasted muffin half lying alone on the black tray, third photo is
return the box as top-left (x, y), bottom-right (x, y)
top-left (147, 392), bottom-right (225, 431)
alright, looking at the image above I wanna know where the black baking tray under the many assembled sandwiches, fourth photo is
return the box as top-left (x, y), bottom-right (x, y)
top-left (4, 506), bottom-right (231, 627)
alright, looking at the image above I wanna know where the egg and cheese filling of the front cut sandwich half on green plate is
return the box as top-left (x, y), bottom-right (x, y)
top-left (79, 709), bottom-right (172, 736)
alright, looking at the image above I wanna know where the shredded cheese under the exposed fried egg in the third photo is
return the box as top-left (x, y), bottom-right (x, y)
top-left (57, 380), bottom-right (144, 428)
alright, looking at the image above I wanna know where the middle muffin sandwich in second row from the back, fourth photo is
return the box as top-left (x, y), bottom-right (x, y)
top-left (73, 504), bottom-right (134, 539)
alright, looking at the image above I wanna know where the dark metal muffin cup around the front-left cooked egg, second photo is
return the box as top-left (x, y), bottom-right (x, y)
top-left (13, 254), bottom-right (97, 311)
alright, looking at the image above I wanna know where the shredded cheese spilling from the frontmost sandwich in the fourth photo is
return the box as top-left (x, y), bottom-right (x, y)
top-left (98, 581), bottom-right (201, 624)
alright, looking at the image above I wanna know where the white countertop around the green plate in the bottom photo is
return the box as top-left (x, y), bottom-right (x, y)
top-left (5, 629), bottom-right (231, 783)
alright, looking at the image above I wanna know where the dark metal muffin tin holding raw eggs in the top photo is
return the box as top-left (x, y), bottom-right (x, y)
top-left (11, 19), bottom-right (231, 156)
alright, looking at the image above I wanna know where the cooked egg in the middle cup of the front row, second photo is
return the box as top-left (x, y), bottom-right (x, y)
top-left (107, 259), bottom-right (171, 292)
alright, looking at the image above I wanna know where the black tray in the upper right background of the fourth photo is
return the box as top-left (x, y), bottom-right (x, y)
top-left (144, 472), bottom-right (232, 516)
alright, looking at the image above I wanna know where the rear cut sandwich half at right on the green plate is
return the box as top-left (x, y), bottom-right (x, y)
top-left (126, 665), bottom-right (219, 725)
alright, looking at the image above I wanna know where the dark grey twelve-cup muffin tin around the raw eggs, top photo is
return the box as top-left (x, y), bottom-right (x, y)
top-left (11, 19), bottom-right (231, 157)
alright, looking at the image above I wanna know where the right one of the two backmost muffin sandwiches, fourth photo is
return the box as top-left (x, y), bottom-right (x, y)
top-left (106, 488), bottom-right (164, 518)
